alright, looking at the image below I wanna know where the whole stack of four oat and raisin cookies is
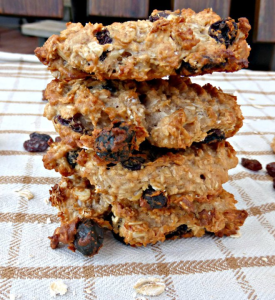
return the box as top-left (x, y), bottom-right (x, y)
top-left (35, 9), bottom-right (250, 255)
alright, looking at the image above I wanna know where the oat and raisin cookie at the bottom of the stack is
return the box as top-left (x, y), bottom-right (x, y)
top-left (50, 178), bottom-right (247, 256)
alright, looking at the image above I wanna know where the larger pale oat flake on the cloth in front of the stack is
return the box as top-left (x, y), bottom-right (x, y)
top-left (134, 277), bottom-right (166, 296)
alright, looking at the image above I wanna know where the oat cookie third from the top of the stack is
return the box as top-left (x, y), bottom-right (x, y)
top-left (43, 141), bottom-right (238, 201)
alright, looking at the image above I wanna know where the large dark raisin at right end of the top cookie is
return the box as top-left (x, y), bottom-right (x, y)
top-left (208, 18), bottom-right (238, 48)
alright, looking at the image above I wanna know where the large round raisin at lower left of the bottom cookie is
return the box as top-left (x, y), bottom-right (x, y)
top-left (74, 219), bottom-right (104, 256)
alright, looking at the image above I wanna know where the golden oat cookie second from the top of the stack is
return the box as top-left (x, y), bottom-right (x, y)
top-left (44, 76), bottom-right (243, 150)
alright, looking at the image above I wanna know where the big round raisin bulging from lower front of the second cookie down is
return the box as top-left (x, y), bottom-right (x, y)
top-left (95, 122), bottom-right (136, 163)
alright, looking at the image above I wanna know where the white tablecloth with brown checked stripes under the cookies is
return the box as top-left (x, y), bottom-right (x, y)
top-left (0, 53), bottom-right (275, 300)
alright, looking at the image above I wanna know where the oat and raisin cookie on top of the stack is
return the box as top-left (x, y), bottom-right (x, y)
top-left (35, 9), bottom-right (251, 81)
